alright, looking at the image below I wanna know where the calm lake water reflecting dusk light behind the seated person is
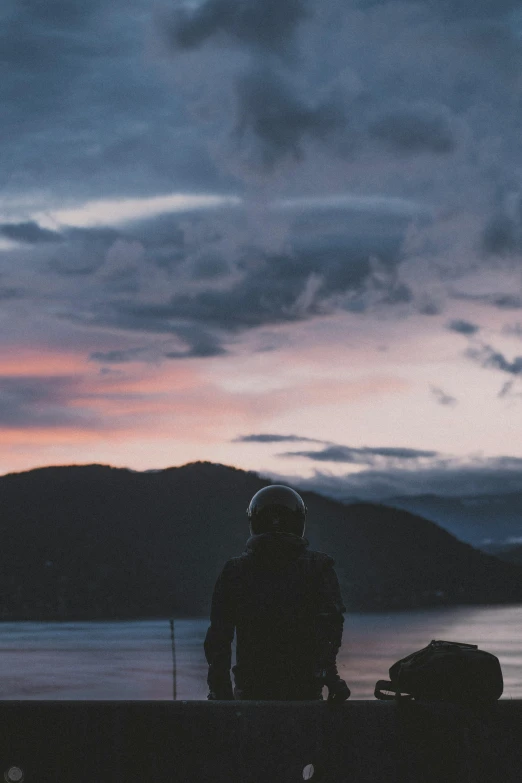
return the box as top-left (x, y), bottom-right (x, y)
top-left (0, 605), bottom-right (522, 699)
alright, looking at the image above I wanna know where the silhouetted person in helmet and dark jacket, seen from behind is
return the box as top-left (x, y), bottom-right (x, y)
top-left (205, 484), bottom-right (350, 701)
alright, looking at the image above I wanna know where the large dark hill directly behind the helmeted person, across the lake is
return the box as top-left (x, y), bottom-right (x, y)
top-left (0, 462), bottom-right (522, 619)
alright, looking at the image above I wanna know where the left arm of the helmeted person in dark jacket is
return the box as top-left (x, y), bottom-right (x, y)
top-left (204, 561), bottom-right (235, 700)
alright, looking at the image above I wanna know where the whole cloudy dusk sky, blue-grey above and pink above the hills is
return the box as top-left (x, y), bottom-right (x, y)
top-left (0, 0), bottom-right (522, 496)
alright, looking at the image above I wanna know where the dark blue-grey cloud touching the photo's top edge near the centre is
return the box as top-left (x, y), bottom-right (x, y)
top-left (169, 0), bottom-right (307, 53)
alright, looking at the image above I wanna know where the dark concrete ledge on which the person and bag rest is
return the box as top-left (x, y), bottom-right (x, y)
top-left (0, 701), bottom-right (522, 783)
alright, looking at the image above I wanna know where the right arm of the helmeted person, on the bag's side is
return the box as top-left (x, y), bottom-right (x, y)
top-left (317, 557), bottom-right (350, 701)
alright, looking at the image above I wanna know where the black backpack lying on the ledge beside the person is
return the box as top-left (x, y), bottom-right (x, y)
top-left (375, 640), bottom-right (504, 705)
